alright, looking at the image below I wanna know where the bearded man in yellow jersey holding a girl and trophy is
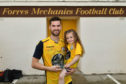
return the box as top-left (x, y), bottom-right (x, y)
top-left (32, 17), bottom-right (75, 84)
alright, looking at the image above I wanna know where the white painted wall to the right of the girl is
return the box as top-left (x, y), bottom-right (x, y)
top-left (80, 17), bottom-right (126, 74)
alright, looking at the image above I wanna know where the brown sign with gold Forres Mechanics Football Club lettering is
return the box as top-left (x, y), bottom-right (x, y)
top-left (0, 6), bottom-right (126, 17)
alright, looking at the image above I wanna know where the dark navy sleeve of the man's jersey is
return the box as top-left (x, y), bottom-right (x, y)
top-left (33, 41), bottom-right (43, 59)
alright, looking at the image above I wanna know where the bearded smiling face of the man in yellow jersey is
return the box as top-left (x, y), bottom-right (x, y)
top-left (50, 21), bottom-right (61, 36)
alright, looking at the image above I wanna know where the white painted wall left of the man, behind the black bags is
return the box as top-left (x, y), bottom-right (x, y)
top-left (0, 17), bottom-right (46, 75)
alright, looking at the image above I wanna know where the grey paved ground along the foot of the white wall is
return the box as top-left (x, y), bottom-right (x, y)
top-left (0, 72), bottom-right (126, 84)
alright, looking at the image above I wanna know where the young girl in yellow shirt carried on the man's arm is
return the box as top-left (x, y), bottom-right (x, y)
top-left (59, 29), bottom-right (83, 84)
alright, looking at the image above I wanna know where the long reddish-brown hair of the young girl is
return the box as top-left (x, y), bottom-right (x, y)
top-left (64, 29), bottom-right (83, 51)
